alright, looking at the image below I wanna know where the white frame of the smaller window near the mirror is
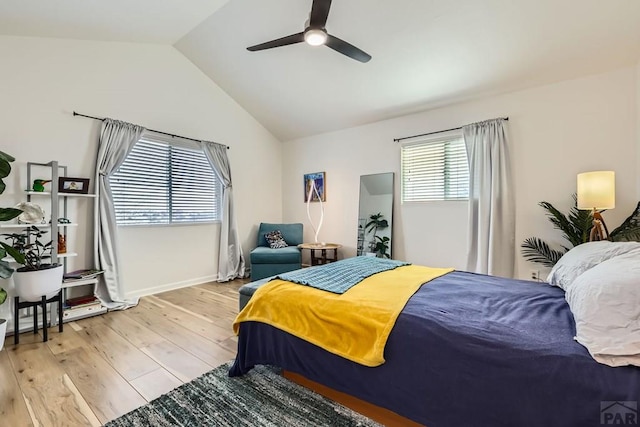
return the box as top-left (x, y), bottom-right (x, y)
top-left (400, 130), bottom-right (470, 204)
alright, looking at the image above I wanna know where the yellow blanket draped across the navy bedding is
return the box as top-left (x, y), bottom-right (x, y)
top-left (233, 265), bottom-right (453, 366)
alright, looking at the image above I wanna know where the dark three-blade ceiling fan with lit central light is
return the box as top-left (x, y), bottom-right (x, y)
top-left (247, 0), bottom-right (371, 62)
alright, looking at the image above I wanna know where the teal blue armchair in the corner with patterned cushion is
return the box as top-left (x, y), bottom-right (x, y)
top-left (250, 222), bottom-right (302, 281)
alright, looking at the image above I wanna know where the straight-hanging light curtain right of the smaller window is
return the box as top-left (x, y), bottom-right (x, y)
top-left (462, 119), bottom-right (515, 277)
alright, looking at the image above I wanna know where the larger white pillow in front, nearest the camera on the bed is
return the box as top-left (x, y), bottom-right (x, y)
top-left (565, 249), bottom-right (640, 366)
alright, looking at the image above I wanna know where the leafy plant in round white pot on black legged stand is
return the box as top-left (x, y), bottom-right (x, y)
top-left (3, 225), bottom-right (63, 301)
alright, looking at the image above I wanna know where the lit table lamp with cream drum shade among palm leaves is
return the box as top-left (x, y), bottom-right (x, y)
top-left (577, 171), bottom-right (616, 241)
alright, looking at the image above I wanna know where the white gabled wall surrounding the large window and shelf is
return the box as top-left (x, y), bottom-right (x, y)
top-left (0, 37), bottom-right (282, 306)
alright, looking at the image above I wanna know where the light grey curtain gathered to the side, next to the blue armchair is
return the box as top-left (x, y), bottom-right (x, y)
top-left (200, 141), bottom-right (245, 282)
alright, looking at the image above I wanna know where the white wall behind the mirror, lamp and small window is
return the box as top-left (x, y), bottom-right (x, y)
top-left (283, 67), bottom-right (640, 278)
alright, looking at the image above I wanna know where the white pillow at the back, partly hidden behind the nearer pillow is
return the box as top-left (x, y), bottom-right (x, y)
top-left (547, 240), bottom-right (640, 291)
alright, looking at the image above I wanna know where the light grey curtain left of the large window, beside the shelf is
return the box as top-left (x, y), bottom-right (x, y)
top-left (94, 119), bottom-right (145, 310)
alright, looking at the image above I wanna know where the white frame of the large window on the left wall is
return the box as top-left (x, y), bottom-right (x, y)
top-left (109, 131), bottom-right (223, 227)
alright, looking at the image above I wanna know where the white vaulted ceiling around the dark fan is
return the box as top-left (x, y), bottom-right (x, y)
top-left (0, 0), bottom-right (640, 140)
